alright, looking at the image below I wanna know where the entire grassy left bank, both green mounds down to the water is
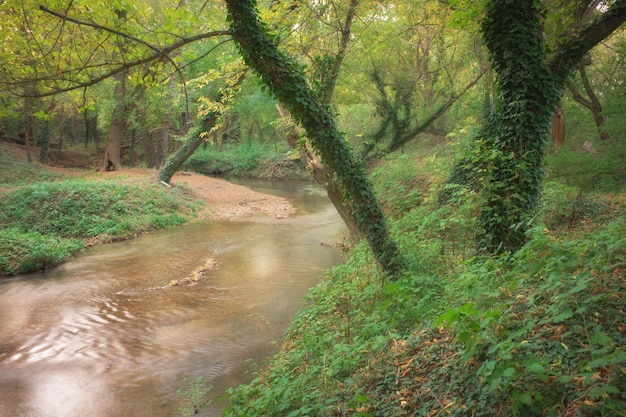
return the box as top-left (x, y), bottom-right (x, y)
top-left (0, 155), bottom-right (200, 276)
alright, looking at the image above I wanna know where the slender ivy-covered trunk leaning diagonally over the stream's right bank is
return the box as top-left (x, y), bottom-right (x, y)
top-left (226, 0), bottom-right (404, 275)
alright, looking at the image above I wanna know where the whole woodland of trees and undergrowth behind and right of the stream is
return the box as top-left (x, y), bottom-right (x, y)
top-left (0, 0), bottom-right (626, 416)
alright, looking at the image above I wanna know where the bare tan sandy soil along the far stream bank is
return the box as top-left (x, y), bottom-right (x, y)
top-left (0, 143), bottom-right (295, 220)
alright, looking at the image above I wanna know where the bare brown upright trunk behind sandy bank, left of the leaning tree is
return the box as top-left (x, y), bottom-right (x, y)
top-left (101, 71), bottom-right (128, 172)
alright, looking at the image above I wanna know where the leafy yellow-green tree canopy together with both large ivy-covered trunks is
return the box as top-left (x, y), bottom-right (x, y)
top-left (0, 0), bottom-right (626, 262)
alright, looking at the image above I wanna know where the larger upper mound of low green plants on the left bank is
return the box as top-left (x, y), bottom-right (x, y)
top-left (0, 180), bottom-right (185, 238)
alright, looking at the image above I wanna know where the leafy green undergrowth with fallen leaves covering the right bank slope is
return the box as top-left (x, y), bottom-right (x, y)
top-left (224, 154), bottom-right (626, 417)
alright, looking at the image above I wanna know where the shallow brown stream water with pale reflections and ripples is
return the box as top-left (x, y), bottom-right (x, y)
top-left (0, 183), bottom-right (345, 417)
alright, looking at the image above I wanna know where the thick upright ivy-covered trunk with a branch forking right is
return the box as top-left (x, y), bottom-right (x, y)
top-left (450, 0), bottom-right (626, 253)
